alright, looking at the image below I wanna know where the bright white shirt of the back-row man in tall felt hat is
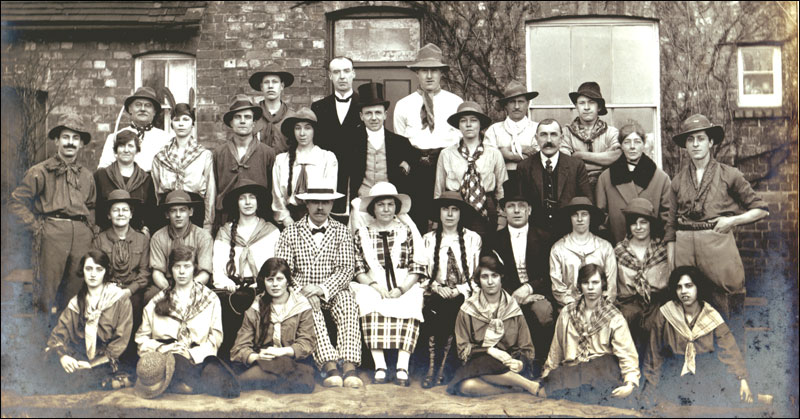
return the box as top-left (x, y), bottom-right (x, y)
top-left (394, 90), bottom-right (464, 150)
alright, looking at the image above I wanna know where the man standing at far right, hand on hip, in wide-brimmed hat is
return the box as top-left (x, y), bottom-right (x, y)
top-left (667, 114), bottom-right (769, 315)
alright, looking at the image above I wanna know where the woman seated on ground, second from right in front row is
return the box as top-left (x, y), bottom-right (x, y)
top-left (542, 263), bottom-right (639, 403)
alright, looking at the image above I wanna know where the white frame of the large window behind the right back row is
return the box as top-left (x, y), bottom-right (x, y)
top-left (525, 17), bottom-right (663, 168)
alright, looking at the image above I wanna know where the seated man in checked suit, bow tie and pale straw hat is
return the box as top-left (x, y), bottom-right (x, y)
top-left (275, 187), bottom-right (364, 388)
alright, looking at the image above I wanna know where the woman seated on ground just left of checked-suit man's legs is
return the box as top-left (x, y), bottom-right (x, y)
top-left (231, 258), bottom-right (316, 393)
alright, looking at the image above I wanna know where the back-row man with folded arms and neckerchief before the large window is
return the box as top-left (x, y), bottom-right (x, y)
top-left (561, 81), bottom-right (622, 197)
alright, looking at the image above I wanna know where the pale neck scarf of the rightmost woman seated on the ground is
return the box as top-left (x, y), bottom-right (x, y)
top-left (660, 301), bottom-right (725, 377)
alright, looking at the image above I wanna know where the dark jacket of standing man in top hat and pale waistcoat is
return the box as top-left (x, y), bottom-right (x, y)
top-left (352, 126), bottom-right (419, 198)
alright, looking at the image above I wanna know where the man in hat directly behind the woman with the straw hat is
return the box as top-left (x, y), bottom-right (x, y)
top-left (150, 189), bottom-right (214, 289)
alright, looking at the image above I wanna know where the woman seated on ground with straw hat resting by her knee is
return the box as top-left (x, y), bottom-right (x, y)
top-left (136, 245), bottom-right (239, 398)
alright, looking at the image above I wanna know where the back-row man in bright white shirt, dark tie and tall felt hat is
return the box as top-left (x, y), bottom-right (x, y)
top-left (394, 44), bottom-right (464, 232)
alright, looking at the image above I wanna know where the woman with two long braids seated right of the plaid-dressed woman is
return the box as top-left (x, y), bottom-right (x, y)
top-left (422, 191), bottom-right (481, 388)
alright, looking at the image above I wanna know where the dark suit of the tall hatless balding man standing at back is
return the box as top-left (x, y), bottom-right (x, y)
top-left (311, 92), bottom-right (361, 214)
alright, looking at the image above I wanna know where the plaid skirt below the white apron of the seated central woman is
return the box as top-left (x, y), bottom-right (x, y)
top-left (361, 313), bottom-right (420, 352)
